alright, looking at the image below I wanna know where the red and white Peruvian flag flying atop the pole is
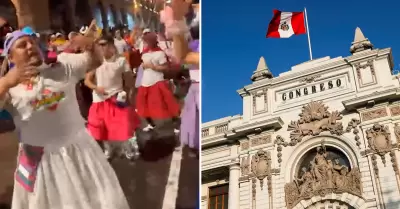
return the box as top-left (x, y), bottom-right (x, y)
top-left (267, 9), bottom-right (306, 38)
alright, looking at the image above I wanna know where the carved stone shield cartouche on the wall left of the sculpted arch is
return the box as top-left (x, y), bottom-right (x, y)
top-left (251, 150), bottom-right (271, 189)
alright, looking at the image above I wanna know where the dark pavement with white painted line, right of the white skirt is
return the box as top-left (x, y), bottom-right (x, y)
top-left (111, 139), bottom-right (199, 209)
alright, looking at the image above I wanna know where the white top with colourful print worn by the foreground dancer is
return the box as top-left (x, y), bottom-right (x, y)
top-left (0, 53), bottom-right (90, 149)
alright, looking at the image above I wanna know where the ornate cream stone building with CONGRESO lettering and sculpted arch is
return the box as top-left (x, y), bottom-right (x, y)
top-left (201, 28), bottom-right (400, 209)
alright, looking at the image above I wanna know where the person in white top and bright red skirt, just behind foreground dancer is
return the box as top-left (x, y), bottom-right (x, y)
top-left (85, 37), bottom-right (136, 159)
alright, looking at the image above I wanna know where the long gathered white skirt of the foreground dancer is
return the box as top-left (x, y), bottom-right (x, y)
top-left (12, 134), bottom-right (129, 209)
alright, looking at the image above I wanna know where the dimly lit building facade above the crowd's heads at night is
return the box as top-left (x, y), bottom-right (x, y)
top-left (0, 0), bottom-right (161, 31)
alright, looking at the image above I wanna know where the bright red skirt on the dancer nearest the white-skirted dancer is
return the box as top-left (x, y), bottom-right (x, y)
top-left (87, 96), bottom-right (139, 141)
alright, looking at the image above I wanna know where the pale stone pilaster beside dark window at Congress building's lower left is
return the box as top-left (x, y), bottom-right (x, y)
top-left (228, 161), bottom-right (240, 209)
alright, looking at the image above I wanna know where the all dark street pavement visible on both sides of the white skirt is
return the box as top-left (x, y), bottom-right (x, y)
top-left (0, 134), bottom-right (199, 209)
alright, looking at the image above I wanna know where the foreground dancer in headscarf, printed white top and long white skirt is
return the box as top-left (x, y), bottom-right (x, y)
top-left (0, 31), bottom-right (129, 209)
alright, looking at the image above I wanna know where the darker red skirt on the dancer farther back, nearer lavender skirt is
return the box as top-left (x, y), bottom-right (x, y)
top-left (136, 80), bottom-right (180, 120)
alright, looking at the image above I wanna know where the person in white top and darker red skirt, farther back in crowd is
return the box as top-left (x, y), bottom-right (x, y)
top-left (136, 32), bottom-right (180, 140)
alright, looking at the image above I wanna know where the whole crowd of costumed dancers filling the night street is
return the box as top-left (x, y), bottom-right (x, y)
top-left (0, 0), bottom-right (200, 209)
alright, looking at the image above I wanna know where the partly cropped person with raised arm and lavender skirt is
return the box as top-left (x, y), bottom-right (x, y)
top-left (161, 0), bottom-right (200, 156)
